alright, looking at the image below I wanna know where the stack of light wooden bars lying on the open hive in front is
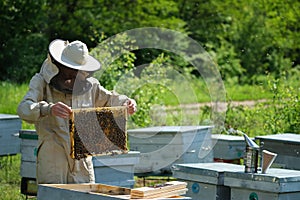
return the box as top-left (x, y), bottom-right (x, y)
top-left (130, 181), bottom-right (187, 199)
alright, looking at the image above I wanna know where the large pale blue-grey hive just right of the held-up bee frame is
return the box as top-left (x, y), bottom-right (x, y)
top-left (127, 126), bottom-right (213, 174)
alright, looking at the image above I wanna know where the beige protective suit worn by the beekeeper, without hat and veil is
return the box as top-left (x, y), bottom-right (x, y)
top-left (18, 58), bottom-right (128, 184)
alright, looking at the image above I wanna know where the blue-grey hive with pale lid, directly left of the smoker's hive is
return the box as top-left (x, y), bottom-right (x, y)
top-left (173, 162), bottom-right (244, 200)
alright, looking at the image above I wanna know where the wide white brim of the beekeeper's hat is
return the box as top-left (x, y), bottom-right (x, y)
top-left (49, 39), bottom-right (101, 72)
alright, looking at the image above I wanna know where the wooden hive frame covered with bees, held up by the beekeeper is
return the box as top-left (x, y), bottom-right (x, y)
top-left (69, 106), bottom-right (128, 159)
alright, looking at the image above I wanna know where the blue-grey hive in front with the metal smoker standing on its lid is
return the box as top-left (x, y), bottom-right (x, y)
top-left (224, 168), bottom-right (300, 200)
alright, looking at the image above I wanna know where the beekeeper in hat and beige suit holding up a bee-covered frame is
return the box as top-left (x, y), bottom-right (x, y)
top-left (18, 39), bottom-right (136, 184)
